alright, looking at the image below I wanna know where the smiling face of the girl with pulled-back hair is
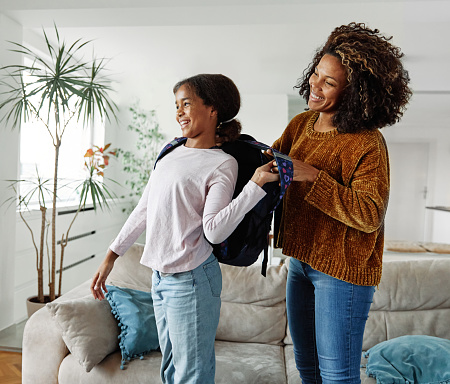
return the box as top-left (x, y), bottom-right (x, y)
top-left (175, 84), bottom-right (217, 146)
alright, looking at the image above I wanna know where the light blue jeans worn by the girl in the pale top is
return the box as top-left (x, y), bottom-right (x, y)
top-left (152, 255), bottom-right (222, 384)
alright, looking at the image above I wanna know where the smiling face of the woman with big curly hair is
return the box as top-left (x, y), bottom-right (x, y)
top-left (308, 55), bottom-right (348, 113)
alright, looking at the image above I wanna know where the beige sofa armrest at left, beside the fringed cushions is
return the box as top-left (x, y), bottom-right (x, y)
top-left (22, 307), bottom-right (69, 384)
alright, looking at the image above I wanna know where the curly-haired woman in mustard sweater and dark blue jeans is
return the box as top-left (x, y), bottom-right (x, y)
top-left (273, 23), bottom-right (411, 384)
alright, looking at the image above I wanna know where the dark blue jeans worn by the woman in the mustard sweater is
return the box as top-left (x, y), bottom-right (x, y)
top-left (286, 258), bottom-right (375, 384)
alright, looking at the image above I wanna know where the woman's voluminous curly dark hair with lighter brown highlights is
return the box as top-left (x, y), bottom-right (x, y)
top-left (295, 22), bottom-right (412, 132)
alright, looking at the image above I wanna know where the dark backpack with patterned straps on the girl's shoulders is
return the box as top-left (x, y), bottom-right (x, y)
top-left (155, 134), bottom-right (294, 276)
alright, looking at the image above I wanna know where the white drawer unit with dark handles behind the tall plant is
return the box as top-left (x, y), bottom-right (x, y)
top-left (14, 202), bottom-right (128, 323)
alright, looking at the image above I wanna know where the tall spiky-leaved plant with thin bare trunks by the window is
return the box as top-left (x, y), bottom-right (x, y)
top-left (0, 26), bottom-right (117, 312)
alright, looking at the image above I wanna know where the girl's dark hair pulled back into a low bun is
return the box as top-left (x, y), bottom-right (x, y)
top-left (173, 74), bottom-right (241, 141)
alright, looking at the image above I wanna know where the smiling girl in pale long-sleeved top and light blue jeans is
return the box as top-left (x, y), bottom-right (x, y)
top-left (91, 74), bottom-right (279, 384)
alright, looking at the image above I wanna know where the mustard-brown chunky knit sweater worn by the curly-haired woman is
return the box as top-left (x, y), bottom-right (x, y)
top-left (273, 111), bottom-right (389, 286)
